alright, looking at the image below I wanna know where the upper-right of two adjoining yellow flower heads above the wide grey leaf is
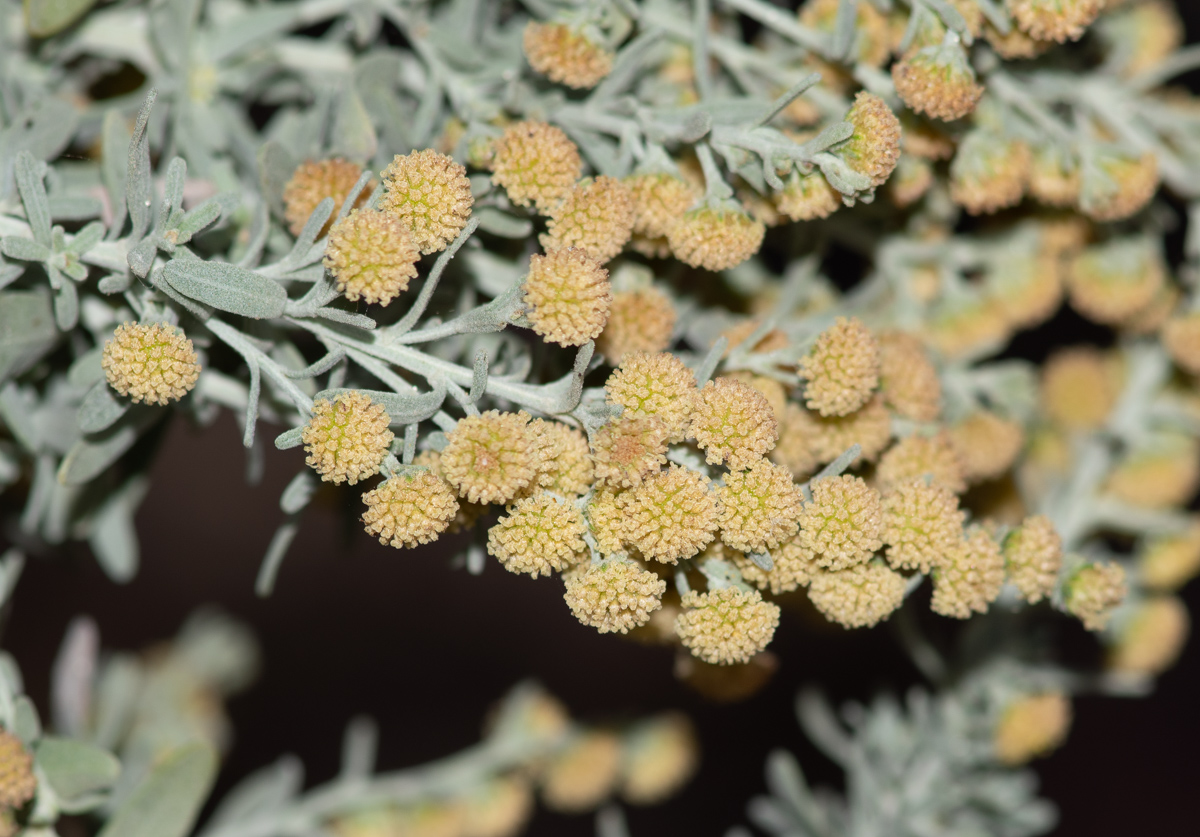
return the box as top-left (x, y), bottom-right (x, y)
top-left (379, 149), bottom-right (475, 254)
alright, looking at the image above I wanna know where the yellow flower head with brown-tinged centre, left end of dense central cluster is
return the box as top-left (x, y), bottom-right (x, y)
top-left (442, 410), bottom-right (539, 502)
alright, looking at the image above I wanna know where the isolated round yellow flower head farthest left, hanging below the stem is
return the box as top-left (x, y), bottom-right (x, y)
top-left (100, 323), bottom-right (200, 405)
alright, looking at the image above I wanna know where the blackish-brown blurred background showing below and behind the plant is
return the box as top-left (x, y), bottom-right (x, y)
top-left (4, 2), bottom-right (1200, 837)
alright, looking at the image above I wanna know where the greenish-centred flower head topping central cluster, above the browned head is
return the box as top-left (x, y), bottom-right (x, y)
top-left (604, 351), bottom-right (696, 442)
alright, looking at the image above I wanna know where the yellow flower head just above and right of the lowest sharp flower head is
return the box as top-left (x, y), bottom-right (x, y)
top-left (716, 459), bottom-right (802, 552)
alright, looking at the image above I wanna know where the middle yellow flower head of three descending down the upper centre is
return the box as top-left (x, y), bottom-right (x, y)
top-left (541, 175), bottom-right (634, 264)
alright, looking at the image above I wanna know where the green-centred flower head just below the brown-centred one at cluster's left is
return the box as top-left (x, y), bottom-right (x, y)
top-left (487, 494), bottom-right (586, 578)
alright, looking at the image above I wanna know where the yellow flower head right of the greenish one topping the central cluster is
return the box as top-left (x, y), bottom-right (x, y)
top-left (690, 378), bottom-right (779, 470)
